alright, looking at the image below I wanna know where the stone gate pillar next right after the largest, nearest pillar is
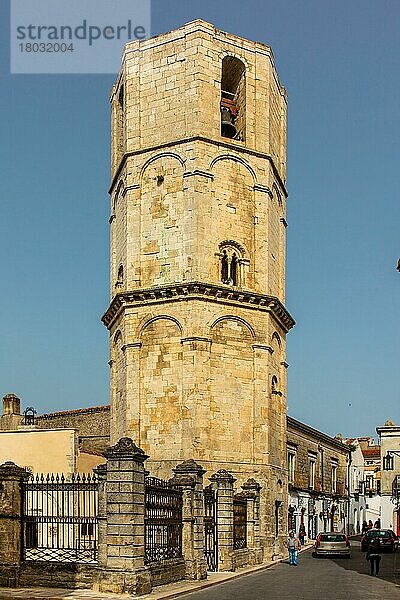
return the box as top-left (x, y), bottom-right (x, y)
top-left (171, 459), bottom-right (207, 579)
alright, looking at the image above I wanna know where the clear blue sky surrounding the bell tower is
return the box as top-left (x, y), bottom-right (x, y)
top-left (0, 0), bottom-right (400, 435)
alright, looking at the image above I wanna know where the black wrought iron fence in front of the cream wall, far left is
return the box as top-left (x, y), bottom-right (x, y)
top-left (21, 473), bottom-right (98, 563)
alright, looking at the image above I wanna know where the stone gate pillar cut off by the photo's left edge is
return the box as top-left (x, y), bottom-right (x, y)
top-left (0, 461), bottom-right (29, 587)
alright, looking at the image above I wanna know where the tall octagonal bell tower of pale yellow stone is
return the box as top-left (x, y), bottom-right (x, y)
top-left (103, 20), bottom-right (294, 556)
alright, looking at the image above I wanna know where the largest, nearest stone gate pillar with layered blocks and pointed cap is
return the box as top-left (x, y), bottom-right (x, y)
top-left (94, 438), bottom-right (151, 595)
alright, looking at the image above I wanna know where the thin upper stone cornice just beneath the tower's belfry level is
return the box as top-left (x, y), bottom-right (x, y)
top-left (109, 135), bottom-right (288, 198)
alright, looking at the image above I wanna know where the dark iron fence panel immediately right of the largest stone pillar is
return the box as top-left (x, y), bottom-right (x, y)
top-left (144, 477), bottom-right (183, 564)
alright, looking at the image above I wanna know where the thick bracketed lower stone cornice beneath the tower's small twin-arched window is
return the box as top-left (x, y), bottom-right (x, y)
top-left (101, 281), bottom-right (295, 332)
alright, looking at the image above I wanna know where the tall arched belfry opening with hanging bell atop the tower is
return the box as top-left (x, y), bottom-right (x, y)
top-left (221, 56), bottom-right (246, 141)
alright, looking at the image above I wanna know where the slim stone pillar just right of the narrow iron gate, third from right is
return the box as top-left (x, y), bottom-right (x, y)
top-left (210, 469), bottom-right (236, 571)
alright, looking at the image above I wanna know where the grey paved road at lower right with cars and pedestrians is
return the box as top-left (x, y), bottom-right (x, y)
top-left (180, 541), bottom-right (400, 600)
